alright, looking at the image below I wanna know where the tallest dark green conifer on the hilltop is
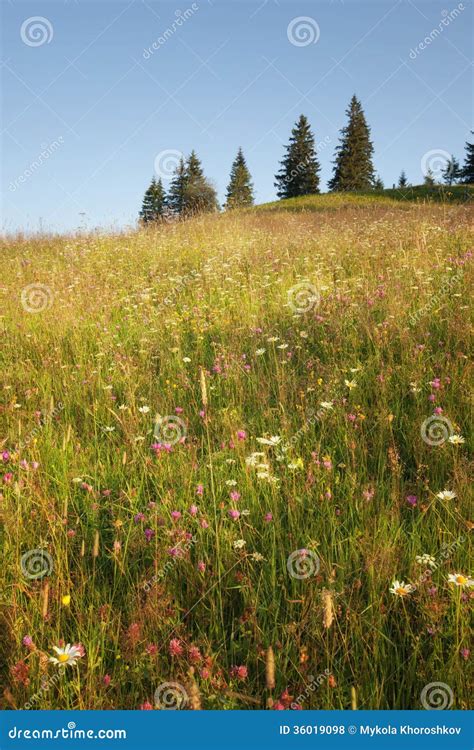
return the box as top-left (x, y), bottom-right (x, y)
top-left (329, 95), bottom-right (374, 191)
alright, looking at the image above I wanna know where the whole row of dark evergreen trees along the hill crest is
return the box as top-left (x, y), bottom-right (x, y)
top-left (140, 95), bottom-right (474, 224)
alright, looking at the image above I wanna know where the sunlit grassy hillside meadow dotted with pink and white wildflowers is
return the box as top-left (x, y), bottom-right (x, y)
top-left (0, 196), bottom-right (473, 710)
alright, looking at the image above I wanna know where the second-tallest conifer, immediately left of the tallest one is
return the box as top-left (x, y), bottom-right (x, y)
top-left (275, 115), bottom-right (321, 198)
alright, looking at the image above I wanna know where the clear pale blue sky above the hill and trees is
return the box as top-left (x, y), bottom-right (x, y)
top-left (0, 0), bottom-right (472, 232)
